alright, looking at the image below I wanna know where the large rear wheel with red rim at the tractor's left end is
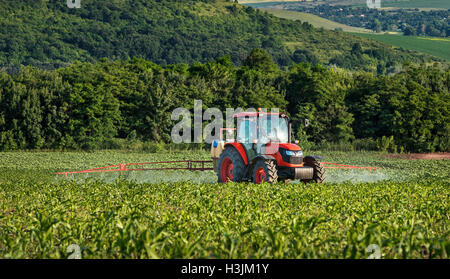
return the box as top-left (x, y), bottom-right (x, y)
top-left (217, 147), bottom-right (245, 183)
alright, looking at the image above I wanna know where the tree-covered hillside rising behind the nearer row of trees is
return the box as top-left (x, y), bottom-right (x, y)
top-left (0, 0), bottom-right (438, 72)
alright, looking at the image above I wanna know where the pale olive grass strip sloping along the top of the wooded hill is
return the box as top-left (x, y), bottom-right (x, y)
top-left (262, 9), bottom-right (373, 33)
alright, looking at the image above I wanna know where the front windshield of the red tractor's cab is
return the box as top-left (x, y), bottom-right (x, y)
top-left (259, 115), bottom-right (289, 143)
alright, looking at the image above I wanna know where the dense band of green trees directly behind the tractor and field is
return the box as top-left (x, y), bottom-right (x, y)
top-left (0, 47), bottom-right (450, 152)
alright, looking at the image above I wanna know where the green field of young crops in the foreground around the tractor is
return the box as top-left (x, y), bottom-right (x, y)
top-left (0, 151), bottom-right (450, 258)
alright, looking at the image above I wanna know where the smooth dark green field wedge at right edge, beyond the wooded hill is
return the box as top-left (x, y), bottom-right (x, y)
top-left (355, 33), bottom-right (450, 61)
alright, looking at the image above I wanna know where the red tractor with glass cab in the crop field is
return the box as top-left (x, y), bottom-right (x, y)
top-left (211, 112), bottom-right (325, 184)
